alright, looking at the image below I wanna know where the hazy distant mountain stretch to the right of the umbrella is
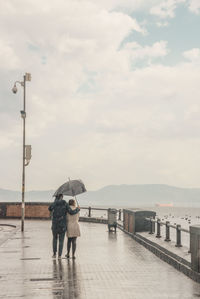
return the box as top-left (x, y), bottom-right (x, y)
top-left (81, 184), bottom-right (200, 207)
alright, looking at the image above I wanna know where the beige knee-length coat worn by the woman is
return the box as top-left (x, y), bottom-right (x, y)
top-left (66, 206), bottom-right (81, 238)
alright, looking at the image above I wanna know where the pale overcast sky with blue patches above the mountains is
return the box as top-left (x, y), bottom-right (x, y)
top-left (0, 0), bottom-right (200, 190)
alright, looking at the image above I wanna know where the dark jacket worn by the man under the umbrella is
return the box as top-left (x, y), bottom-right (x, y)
top-left (48, 199), bottom-right (80, 234)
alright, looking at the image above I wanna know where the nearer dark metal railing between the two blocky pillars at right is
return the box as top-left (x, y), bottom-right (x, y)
top-left (145, 218), bottom-right (190, 252)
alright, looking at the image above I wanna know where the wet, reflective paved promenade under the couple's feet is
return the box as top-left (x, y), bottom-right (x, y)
top-left (0, 219), bottom-right (200, 299)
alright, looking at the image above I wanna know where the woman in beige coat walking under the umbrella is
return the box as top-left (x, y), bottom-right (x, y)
top-left (66, 199), bottom-right (81, 259)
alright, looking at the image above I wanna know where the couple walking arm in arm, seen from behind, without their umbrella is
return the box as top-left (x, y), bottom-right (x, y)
top-left (48, 194), bottom-right (80, 259)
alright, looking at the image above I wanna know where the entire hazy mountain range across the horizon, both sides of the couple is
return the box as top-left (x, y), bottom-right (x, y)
top-left (0, 184), bottom-right (200, 207)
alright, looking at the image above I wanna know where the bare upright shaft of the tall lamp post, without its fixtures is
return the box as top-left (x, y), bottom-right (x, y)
top-left (21, 76), bottom-right (26, 232)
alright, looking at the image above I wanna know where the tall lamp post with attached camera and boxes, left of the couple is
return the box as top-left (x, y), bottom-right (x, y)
top-left (12, 73), bottom-right (31, 232)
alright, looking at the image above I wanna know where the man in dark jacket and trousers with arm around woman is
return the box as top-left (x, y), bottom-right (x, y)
top-left (48, 194), bottom-right (80, 259)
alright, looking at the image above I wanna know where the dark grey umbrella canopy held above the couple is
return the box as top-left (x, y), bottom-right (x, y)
top-left (53, 180), bottom-right (87, 196)
